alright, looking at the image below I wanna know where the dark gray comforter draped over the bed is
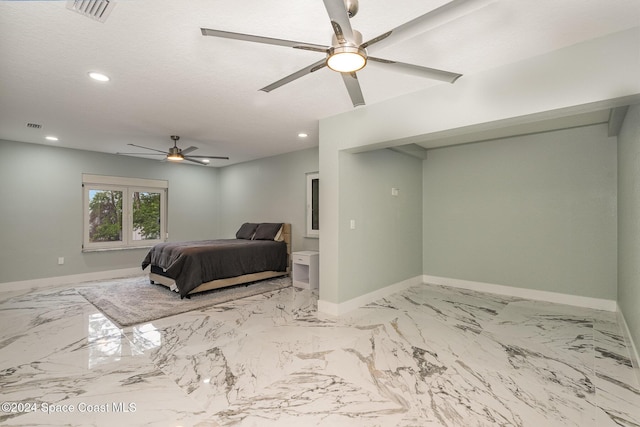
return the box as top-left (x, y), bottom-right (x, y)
top-left (142, 239), bottom-right (288, 297)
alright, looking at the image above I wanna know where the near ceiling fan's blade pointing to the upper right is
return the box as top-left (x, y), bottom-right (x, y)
top-left (361, 0), bottom-right (497, 49)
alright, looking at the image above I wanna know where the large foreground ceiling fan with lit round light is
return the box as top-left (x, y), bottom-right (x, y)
top-left (200, 0), bottom-right (487, 107)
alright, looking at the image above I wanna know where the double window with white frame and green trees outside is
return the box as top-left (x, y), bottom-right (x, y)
top-left (82, 174), bottom-right (169, 251)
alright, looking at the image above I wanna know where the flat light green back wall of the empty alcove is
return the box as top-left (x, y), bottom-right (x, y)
top-left (423, 125), bottom-right (617, 300)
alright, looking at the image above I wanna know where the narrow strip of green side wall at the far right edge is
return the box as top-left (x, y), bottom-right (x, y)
top-left (618, 105), bottom-right (640, 356)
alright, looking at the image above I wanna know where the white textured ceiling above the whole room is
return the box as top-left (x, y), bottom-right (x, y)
top-left (0, 0), bottom-right (640, 166)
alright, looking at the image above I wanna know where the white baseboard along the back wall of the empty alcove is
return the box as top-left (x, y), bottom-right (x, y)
top-left (423, 274), bottom-right (618, 312)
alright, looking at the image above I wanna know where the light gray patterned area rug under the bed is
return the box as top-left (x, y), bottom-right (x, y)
top-left (76, 276), bottom-right (291, 327)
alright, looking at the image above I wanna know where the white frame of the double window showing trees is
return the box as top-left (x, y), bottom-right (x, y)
top-left (82, 174), bottom-right (169, 252)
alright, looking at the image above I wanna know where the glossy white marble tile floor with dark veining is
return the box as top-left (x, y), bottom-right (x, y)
top-left (0, 278), bottom-right (640, 427)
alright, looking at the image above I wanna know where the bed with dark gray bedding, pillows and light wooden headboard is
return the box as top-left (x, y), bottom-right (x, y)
top-left (142, 223), bottom-right (291, 298)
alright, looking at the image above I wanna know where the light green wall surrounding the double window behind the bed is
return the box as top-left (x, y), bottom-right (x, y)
top-left (0, 140), bottom-right (219, 283)
